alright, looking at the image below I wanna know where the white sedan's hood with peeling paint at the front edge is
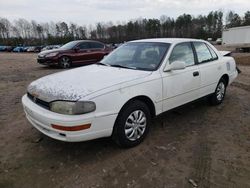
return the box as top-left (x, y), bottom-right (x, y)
top-left (28, 65), bottom-right (151, 102)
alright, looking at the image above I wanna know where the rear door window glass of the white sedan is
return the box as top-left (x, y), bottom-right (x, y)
top-left (194, 42), bottom-right (213, 63)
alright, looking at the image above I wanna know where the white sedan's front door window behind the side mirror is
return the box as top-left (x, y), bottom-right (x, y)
top-left (169, 42), bottom-right (194, 66)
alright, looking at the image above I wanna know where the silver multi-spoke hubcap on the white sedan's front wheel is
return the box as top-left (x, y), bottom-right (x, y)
top-left (125, 110), bottom-right (147, 141)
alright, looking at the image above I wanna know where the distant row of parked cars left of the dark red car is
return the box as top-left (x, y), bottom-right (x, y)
top-left (0, 45), bottom-right (61, 53)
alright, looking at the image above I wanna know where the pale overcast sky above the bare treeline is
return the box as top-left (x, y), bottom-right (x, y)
top-left (0, 0), bottom-right (250, 25)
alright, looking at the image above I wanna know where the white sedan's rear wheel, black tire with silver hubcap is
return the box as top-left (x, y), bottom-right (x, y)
top-left (209, 78), bottom-right (227, 105)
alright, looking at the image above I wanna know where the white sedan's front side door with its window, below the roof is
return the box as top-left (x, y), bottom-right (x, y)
top-left (162, 42), bottom-right (200, 111)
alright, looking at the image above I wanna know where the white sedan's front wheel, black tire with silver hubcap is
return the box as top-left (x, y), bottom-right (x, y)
top-left (112, 100), bottom-right (151, 148)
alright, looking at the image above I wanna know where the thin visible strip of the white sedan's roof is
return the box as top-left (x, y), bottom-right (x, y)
top-left (131, 38), bottom-right (204, 44)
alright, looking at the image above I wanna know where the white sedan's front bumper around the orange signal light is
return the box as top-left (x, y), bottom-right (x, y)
top-left (22, 95), bottom-right (117, 142)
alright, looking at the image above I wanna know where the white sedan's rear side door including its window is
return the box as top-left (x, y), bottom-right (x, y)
top-left (193, 42), bottom-right (223, 97)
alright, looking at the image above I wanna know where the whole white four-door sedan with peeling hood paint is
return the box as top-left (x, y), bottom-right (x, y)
top-left (22, 39), bottom-right (238, 147)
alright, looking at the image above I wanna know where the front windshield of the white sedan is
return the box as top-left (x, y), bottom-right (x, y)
top-left (100, 42), bottom-right (170, 71)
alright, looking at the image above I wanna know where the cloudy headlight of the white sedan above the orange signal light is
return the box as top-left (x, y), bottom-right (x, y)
top-left (50, 101), bottom-right (96, 115)
